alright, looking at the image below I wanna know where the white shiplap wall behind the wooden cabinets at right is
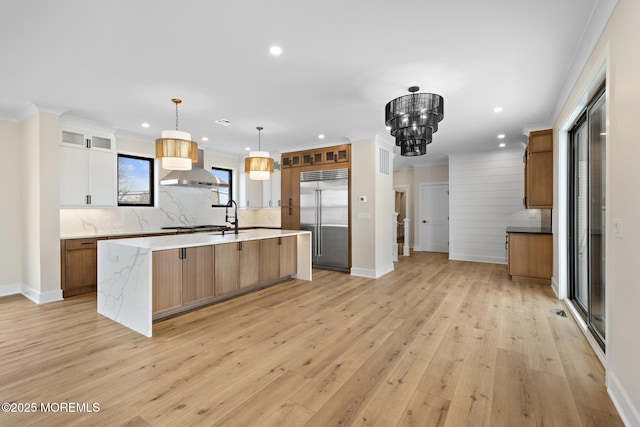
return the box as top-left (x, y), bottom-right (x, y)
top-left (449, 150), bottom-right (540, 264)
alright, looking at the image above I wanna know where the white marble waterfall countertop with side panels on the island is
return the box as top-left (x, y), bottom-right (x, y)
top-left (97, 229), bottom-right (312, 337)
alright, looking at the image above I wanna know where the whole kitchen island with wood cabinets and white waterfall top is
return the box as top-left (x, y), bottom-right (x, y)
top-left (98, 229), bottom-right (311, 337)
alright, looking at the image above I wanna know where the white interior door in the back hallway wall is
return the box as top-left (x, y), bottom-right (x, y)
top-left (420, 184), bottom-right (449, 252)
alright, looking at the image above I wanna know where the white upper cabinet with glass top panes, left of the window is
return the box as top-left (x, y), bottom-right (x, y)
top-left (60, 130), bottom-right (118, 207)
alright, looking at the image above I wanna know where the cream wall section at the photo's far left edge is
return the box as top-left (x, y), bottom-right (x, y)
top-left (0, 120), bottom-right (22, 296)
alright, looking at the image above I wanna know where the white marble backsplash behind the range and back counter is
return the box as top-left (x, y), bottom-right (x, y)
top-left (60, 187), bottom-right (280, 237)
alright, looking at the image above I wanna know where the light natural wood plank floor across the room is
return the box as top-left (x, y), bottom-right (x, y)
top-left (0, 253), bottom-right (622, 426)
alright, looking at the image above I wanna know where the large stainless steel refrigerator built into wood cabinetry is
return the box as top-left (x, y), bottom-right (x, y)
top-left (300, 169), bottom-right (349, 273)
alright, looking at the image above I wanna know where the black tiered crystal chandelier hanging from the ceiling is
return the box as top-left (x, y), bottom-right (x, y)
top-left (385, 86), bottom-right (444, 156)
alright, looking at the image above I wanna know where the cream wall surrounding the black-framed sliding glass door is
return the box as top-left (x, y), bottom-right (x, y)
top-left (553, 0), bottom-right (640, 426)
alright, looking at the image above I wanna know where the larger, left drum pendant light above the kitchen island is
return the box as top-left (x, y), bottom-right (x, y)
top-left (156, 98), bottom-right (198, 170)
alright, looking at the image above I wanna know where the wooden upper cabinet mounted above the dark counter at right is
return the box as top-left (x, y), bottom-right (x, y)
top-left (524, 129), bottom-right (553, 209)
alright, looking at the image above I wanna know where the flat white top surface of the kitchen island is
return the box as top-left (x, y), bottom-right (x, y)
top-left (98, 228), bottom-right (311, 251)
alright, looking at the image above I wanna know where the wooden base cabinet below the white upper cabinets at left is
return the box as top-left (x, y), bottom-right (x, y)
top-left (60, 238), bottom-right (98, 298)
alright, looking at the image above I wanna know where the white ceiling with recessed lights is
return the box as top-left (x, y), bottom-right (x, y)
top-left (0, 0), bottom-right (598, 170)
